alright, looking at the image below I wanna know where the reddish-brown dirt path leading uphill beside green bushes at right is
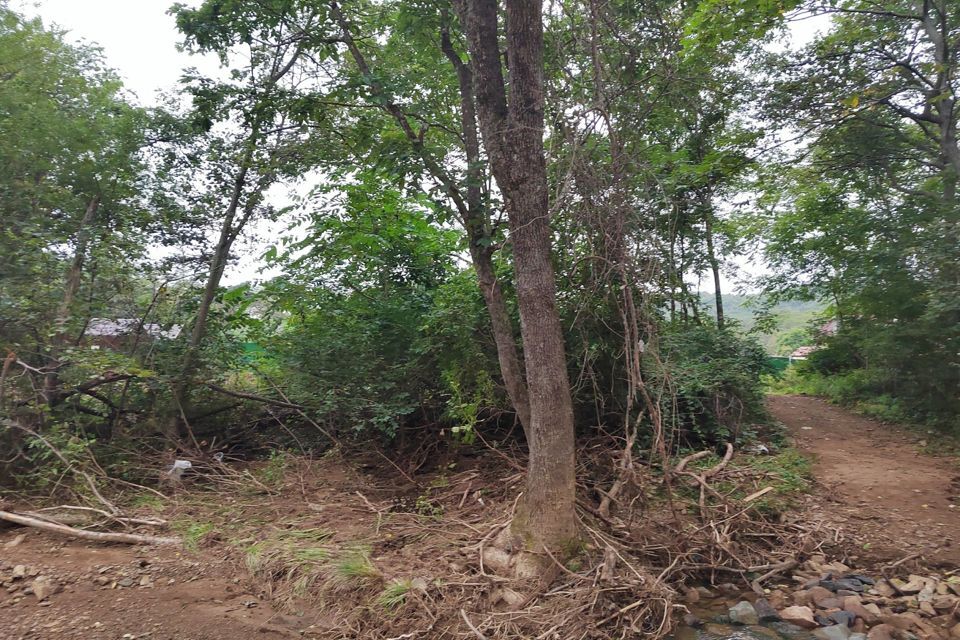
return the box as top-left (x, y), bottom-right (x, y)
top-left (770, 396), bottom-right (960, 566)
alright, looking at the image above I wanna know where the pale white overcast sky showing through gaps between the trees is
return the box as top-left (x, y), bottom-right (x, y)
top-left (10, 0), bottom-right (826, 291)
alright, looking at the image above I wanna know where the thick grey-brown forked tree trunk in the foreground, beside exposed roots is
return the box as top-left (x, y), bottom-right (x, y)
top-left (461, 0), bottom-right (578, 575)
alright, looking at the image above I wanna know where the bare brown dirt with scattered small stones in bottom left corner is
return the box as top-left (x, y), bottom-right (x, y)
top-left (0, 529), bottom-right (322, 640)
